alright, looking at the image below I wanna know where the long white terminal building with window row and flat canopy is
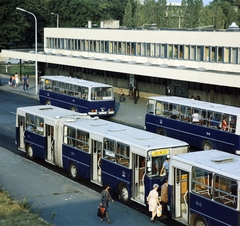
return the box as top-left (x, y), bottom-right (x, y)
top-left (2, 21), bottom-right (240, 106)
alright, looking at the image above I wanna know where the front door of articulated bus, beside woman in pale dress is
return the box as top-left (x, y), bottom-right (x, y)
top-left (132, 153), bottom-right (145, 204)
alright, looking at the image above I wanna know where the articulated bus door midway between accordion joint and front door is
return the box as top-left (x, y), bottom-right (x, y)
top-left (91, 139), bottom-right (102, 184)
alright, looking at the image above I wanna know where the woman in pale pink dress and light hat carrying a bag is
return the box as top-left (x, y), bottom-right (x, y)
top-left (147, 184), bottom-right (160, 222)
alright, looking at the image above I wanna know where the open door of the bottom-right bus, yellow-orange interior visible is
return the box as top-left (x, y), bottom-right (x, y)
top-left (173, 168), bottom-right (189, 222)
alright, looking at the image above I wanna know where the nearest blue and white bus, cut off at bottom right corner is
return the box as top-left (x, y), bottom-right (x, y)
top-left (168, 150), bottom-right (240, 226)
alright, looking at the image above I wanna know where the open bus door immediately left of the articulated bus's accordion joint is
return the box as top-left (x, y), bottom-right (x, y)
top-left (46, 124), bottom-right (55, 164)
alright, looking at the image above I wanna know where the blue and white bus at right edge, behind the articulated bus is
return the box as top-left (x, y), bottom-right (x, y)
top-left (145, 96), bottom-right (240, 154)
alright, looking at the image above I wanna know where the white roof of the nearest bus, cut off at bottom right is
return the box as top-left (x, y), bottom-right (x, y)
top-left (170, 150), bottom-right (240, 180)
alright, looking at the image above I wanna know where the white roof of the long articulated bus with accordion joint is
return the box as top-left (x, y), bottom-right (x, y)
top-left (17, 105), bottom-right (188, 156)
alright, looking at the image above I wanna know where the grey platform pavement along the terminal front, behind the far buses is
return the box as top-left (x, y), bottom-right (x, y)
top-left (0, 74), bottom-right (147, 129)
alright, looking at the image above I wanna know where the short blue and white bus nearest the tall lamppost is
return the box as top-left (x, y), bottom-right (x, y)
top-left (39, 76), bottom-right (115, 117)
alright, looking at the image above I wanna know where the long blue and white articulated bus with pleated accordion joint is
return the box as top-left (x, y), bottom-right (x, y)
top-left (16, 105), bottom-right (189, 205)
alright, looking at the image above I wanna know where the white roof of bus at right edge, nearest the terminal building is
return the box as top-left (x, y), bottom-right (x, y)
top-left (148, 96), bottom-right (240, 115)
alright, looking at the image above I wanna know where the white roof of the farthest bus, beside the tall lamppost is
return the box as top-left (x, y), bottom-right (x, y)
top-left (41, 75), bottom-right (112, 88)
